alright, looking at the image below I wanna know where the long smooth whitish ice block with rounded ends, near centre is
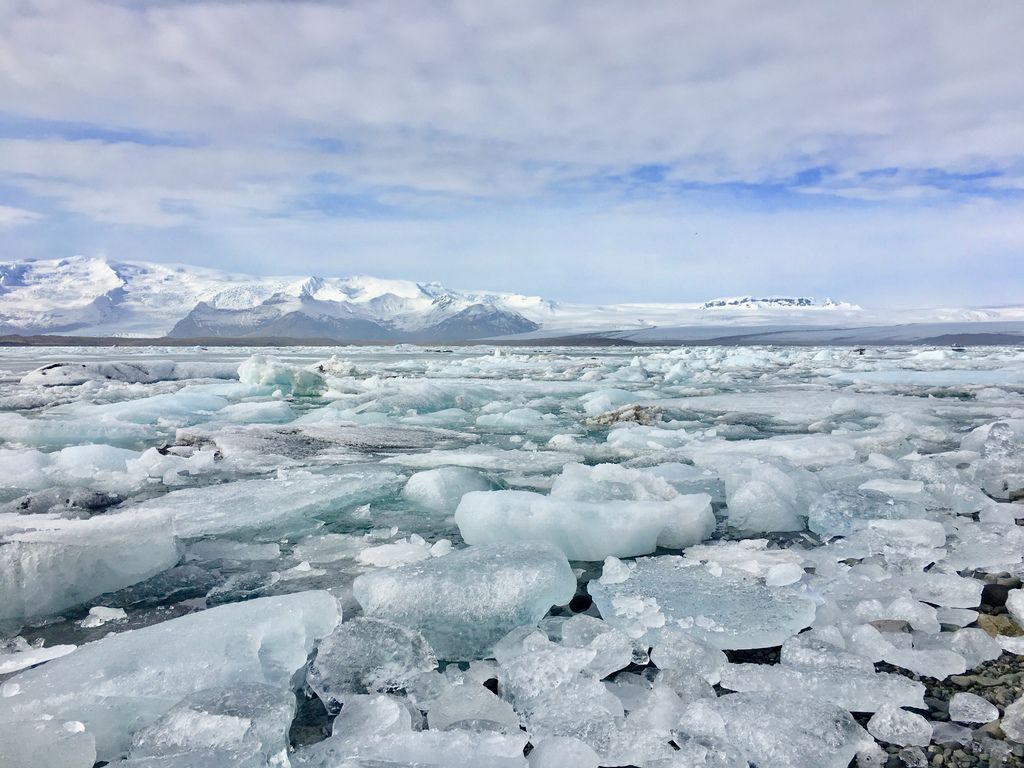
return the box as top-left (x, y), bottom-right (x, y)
top-left (455, 490), bottom-right (715, 560)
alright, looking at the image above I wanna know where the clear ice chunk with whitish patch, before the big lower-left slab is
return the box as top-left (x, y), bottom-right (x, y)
top-left (129, 683), bottom-right (295, 765)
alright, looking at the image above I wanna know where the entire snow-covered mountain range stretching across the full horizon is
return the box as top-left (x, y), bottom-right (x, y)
top-left (0, 257), bottom-right (1024, 342)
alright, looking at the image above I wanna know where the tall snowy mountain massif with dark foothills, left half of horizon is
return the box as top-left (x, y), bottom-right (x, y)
top-left (0, 257), bottom-right (546, 341)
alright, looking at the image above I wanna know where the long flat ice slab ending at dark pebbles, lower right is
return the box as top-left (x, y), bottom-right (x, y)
top-left (721, 664), bottom-right (925, 712)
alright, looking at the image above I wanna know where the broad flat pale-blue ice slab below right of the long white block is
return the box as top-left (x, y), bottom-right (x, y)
top-left (589, 555), bottom-right (815, 650)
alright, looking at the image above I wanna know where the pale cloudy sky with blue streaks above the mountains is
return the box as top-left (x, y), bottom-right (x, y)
top-left (0, 0), bottom-right (1024, 307)
